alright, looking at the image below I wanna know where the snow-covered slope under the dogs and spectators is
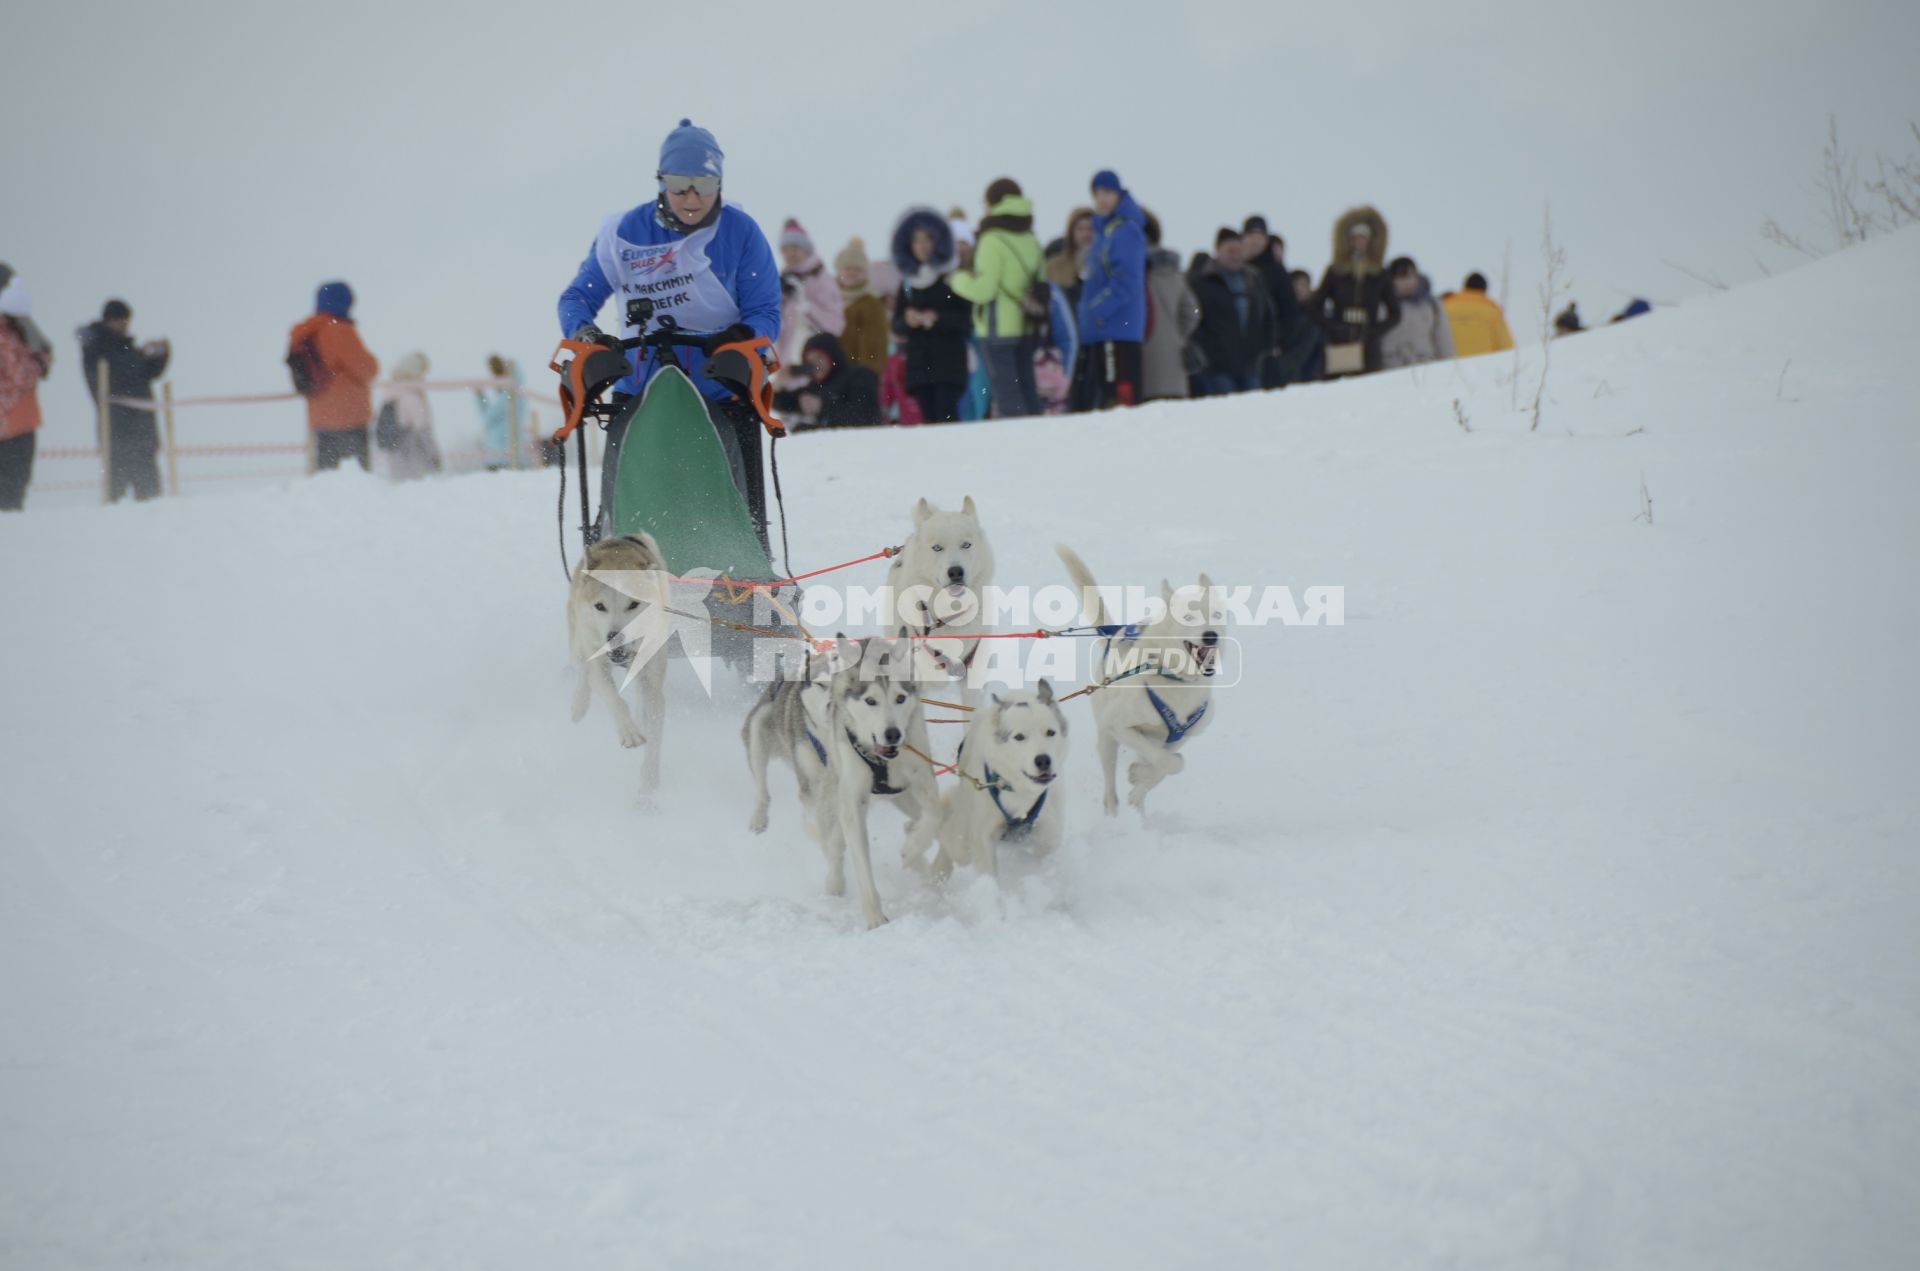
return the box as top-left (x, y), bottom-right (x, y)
top-left (0, 232), bottom-right (1920, 1271)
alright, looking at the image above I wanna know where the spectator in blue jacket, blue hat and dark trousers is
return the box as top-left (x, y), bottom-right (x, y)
top-left (1079, 169), bottom-right (1146, 411)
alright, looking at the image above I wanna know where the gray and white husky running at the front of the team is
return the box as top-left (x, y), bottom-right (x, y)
top-left (743, 639), bottom-right (941, 929)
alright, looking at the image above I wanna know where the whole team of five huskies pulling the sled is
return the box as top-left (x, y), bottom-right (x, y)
top-left (566, 497), bottom-right (1225, 927)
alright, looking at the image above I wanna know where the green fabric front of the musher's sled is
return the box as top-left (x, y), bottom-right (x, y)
top-left (612, 367), bottom-right (778, 582)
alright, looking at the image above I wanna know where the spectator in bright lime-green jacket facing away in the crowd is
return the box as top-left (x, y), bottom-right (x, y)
top-left (947, 177), bottom-right (1043, 419)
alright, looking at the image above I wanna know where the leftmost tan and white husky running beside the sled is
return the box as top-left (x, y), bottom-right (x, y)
top-left (566, 534), bottom-right (670, 791)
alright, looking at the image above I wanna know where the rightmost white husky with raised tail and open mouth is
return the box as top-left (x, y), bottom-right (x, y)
top-left (1056, 547), bottom-right (1227, 816)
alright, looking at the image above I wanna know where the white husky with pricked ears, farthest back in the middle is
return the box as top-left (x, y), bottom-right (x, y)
top-left (887, 495), bottom-right (993, 680)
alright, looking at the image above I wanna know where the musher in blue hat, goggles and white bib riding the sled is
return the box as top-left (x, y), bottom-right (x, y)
top-left (561, 119), bottom-right (780, 545)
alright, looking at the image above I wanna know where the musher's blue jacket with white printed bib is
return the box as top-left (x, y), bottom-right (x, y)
top-left (561, 202), bottom-right (780, 399)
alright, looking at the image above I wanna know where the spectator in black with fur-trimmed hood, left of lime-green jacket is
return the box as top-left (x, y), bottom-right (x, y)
top-left (891, 207), bottom-right (973, 424)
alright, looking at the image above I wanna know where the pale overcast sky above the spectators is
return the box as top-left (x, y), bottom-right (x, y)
top-left (0, 0), bottom-right (1920, 430)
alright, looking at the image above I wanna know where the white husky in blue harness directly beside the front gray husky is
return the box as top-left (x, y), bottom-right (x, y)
top-left (933, 680), bottom-right (1068, 877)
